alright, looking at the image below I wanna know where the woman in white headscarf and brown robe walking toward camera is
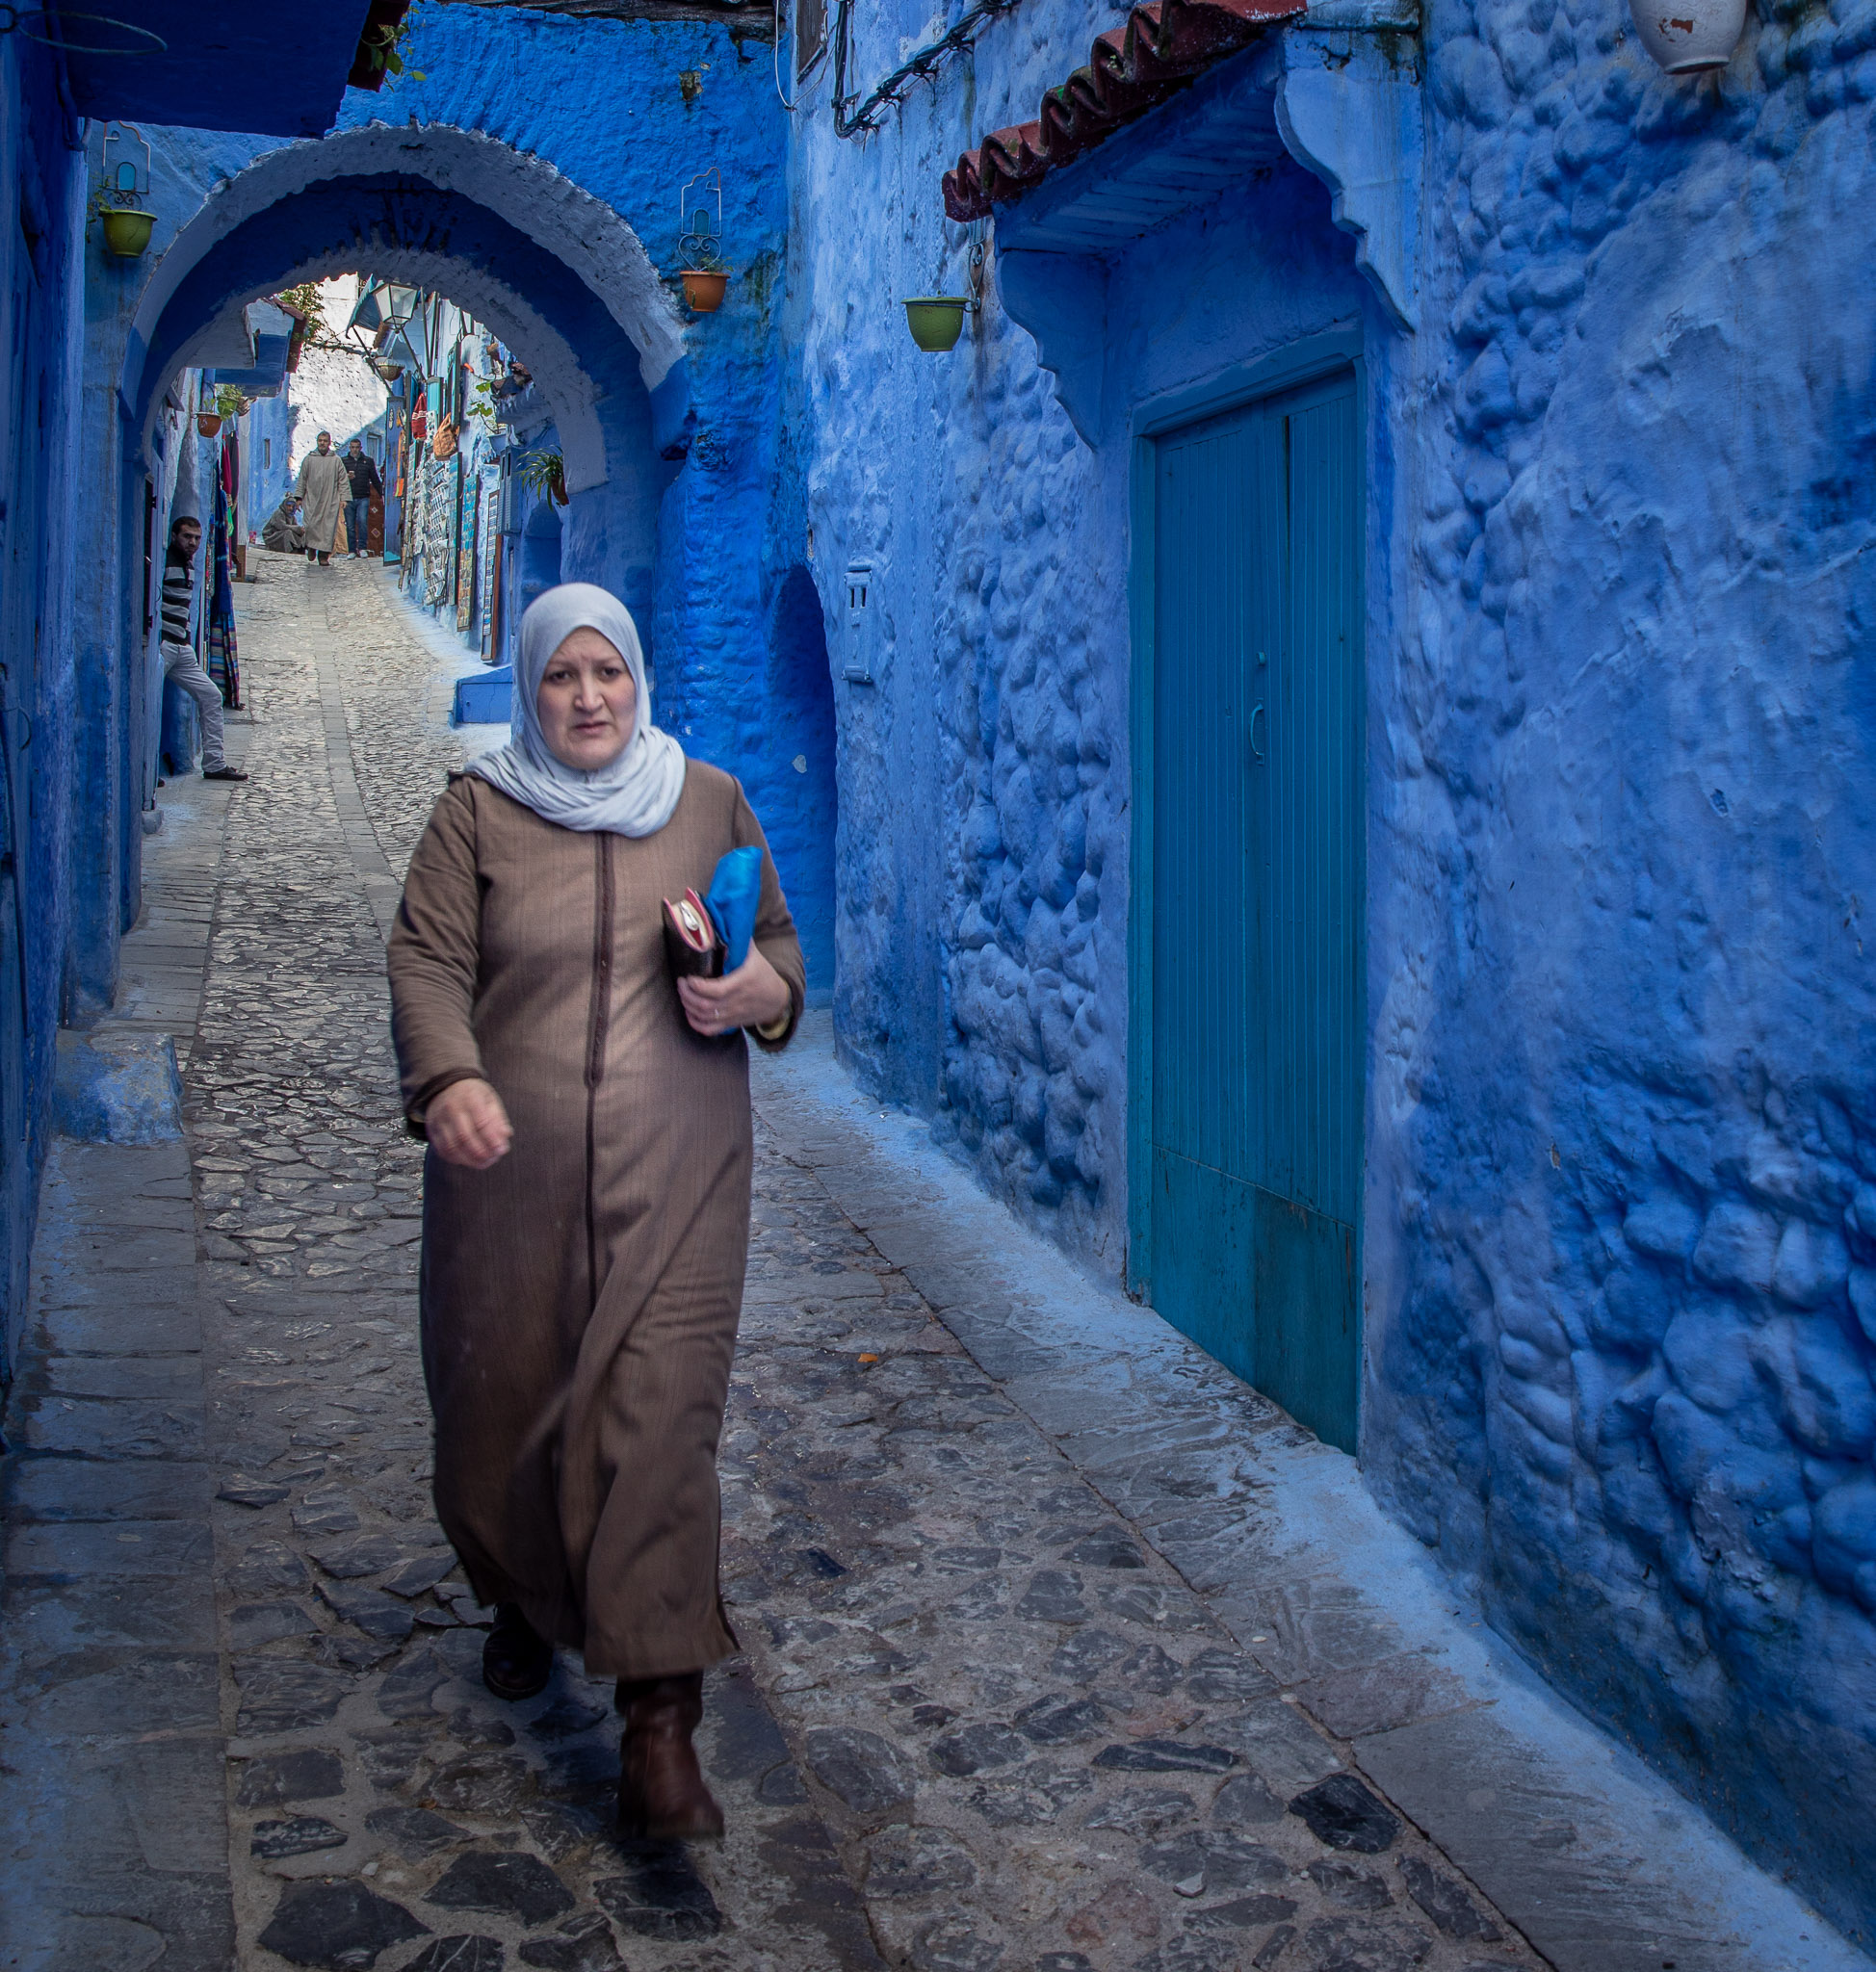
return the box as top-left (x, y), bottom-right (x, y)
top-left (391, 582), bottom-right (803, 1840)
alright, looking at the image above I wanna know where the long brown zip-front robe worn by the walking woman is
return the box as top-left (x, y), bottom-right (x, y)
top-left (391, 762), bottom-right (805, 1678)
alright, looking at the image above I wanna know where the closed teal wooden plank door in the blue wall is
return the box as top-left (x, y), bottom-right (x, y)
top-left (1140, 371), bottom-right (1363, 1449)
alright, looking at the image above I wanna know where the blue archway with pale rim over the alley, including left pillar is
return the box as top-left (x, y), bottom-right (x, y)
top-left (67, 124), bottom-right (692, 1008)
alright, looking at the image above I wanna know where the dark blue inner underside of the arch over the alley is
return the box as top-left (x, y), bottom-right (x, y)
top-left (132, 175), bottom-right (677, 655)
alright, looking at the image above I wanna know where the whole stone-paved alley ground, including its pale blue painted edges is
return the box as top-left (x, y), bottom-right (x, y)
top-left (0, 557), bottom-right (1861, 1972)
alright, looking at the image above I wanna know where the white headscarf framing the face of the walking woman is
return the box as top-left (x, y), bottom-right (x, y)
top-left (470, 582), bottom-right (685, 836)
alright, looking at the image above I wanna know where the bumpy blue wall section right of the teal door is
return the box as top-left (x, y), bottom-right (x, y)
top-left (1363, 0), bottom-right (1876, 1925)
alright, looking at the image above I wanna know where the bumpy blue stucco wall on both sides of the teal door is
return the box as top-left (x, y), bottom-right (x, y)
top-left (791, 0), bottom-right (1876, 1927)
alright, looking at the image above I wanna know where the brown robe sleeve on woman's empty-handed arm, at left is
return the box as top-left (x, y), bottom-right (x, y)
top-left (386, 781), bottom-right (483, 1136)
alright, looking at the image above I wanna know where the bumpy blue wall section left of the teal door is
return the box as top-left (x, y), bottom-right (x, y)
top-left (785, 4), bottom-right (1127, 1230)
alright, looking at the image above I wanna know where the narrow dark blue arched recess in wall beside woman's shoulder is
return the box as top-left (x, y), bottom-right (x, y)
top-left (758, 564), bottom-right (839, 1005)
